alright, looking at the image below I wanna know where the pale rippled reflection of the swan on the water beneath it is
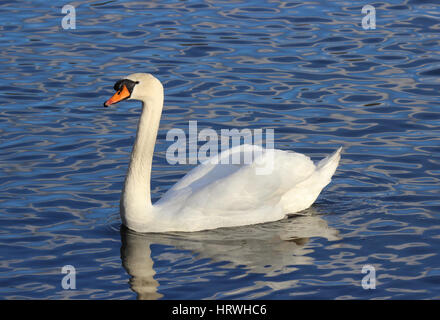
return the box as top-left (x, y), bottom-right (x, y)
top-left (121, 208), bottom-right (339, 299)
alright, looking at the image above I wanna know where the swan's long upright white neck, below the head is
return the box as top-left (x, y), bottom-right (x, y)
top-left (121, 94), bottom-right (163, 225)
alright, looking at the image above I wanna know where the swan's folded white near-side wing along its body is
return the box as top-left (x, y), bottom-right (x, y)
top-left (157, 145), bottom-right (316, 216)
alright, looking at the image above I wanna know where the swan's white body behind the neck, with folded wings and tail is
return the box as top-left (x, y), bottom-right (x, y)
top-left (150, 145), bottom-right (340, 231)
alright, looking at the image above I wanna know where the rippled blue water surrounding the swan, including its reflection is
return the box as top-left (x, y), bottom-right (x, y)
top-left (0, 0), bottom-right (440, 299)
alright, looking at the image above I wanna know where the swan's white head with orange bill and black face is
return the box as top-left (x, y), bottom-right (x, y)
top-left (104, 73), bottom-right (163, 107)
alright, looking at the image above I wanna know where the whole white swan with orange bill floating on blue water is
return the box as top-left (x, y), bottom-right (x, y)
top-left (104, 73), bottom-right (342, 233)
